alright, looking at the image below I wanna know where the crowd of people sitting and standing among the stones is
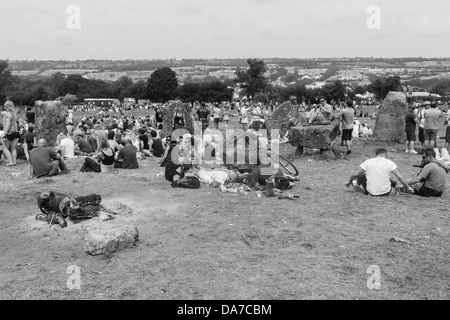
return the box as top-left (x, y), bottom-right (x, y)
top-left (0, 98), bottom-right (450, 196)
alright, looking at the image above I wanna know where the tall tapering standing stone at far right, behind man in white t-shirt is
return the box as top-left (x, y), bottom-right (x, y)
top-left (373, 91), bottom-right (408, 142)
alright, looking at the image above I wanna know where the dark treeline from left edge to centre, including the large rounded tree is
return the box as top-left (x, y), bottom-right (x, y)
top-left (0, 64), bottom-right (233, 105)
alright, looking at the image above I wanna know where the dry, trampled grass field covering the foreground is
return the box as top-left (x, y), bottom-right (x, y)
top-left (0, 112), bottom-right (450, 300)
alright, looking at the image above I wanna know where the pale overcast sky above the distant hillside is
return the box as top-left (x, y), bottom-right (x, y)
top-left (0, 0), bottom-right (450, 60)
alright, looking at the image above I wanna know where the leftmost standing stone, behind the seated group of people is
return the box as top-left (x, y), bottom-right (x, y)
top-left (34, 100), bottom-right (67, 147)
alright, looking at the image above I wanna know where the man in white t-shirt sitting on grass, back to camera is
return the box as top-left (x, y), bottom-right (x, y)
top-left (347, 148), bottom-right (414, 197)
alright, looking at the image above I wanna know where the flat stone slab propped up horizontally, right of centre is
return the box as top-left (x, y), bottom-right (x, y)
top-left (289, 121), bottom-right (339, 150)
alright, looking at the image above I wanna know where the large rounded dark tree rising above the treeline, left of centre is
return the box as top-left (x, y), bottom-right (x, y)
top-left (147, 67), bottom-right (178, 102)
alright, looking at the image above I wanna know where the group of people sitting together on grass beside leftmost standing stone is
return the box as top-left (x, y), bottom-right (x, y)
top-left (29, 121), bottom-right (169, 178)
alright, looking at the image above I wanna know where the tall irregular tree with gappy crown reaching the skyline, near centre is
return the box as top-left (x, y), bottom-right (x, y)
top-left (235, 59), bottom-right (268, 98)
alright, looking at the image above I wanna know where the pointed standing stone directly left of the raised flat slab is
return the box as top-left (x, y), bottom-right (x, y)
top-left (266, 101), bottom-right (306, 137)
